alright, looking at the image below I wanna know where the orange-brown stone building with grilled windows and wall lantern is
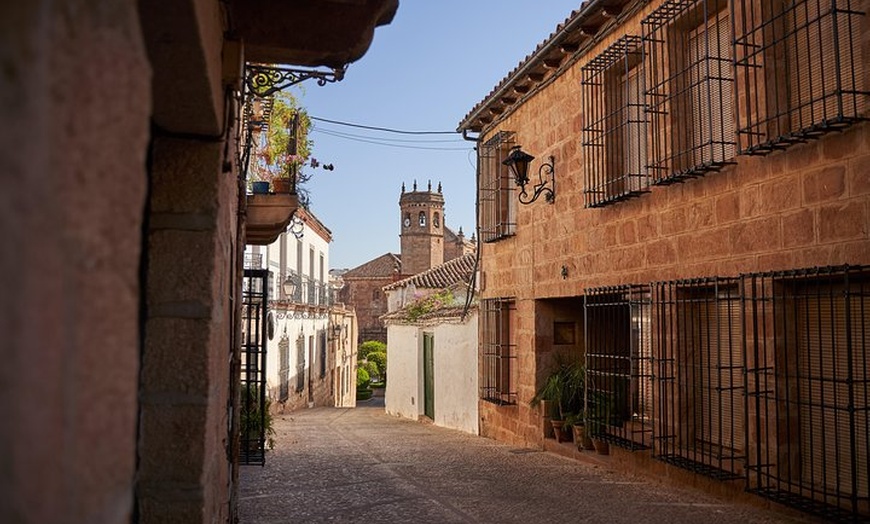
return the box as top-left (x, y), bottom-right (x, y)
top-left (459, 0), bottom-right (870, 520)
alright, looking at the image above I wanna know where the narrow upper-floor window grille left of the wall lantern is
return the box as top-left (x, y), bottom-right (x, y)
top-left (477, 131), bottom-right (517, 242)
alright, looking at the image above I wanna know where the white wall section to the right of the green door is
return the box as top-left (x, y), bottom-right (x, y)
top-left (432, 316), bottom-right (479, 435)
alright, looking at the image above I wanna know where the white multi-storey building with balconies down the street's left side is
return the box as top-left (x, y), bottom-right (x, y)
top-left (245, 208), bottom-right (357, 412)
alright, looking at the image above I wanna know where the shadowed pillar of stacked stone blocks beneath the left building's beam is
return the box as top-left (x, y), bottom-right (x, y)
top-left (139, 136), bottom-right (243, 524)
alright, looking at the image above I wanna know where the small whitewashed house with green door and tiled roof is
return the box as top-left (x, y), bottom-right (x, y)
top-left (381, 253), bottom-right (478, 435)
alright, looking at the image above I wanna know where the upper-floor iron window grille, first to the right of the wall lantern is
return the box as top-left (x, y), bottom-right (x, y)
top-left (581, 35), bottom-right (649, 207)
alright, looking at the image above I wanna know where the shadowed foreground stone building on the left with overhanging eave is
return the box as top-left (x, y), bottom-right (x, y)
top-left (0, 0), bottom-right (398, 524)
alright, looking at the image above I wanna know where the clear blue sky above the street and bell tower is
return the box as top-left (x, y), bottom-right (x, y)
top-left (293, 0), bottom-right (581, 268)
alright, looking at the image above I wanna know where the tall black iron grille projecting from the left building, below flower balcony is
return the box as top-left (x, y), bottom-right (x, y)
top-left (239, 269), bottom-right (269, 465)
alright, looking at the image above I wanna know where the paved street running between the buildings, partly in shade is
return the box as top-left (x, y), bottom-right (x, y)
top-left (240, 399), bottom-right (813, 524)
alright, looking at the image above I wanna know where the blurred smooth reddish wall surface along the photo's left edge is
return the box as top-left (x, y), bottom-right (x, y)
top-left (0, 0), bottom-right (151, 523)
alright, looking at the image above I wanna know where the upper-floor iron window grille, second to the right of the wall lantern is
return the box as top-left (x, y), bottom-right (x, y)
top-left (642, 0), bottom-right (737, 184)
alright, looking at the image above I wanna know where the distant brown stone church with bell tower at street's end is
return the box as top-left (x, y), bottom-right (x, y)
top-left (340, 181), bottom-right (475, 342)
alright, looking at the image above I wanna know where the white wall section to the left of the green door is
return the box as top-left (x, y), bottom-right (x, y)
top-left (384, 324), bottom-right (423, 420)
